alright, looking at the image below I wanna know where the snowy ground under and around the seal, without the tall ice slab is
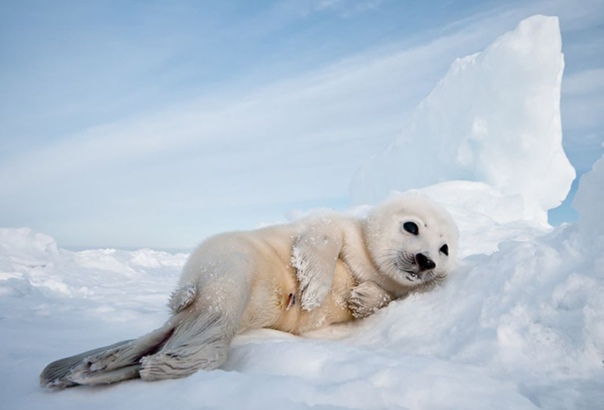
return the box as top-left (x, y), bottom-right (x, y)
top-left (0, 161), bottom-right (604, 410)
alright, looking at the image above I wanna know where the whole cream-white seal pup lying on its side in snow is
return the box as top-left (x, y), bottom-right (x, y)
top-left (40, 193), bottom-right (458, 389)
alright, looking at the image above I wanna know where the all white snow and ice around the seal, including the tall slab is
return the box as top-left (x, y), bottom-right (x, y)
top-left (0, 16), bottom-right (604, 410)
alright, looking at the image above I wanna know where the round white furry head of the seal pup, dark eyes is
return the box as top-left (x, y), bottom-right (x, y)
top-left (364, 193), bottom-right (458, 288)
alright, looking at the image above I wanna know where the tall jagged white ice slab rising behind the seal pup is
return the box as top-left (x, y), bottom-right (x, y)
top-left (350, 16), bottom-right (575, 226)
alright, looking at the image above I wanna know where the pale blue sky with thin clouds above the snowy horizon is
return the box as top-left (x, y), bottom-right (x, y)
top-left (0, 0), bottom-right (604, 249)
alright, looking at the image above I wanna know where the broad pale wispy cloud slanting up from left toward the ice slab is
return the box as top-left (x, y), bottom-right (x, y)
top-left (0, 24), bottom-right (486, 246)
